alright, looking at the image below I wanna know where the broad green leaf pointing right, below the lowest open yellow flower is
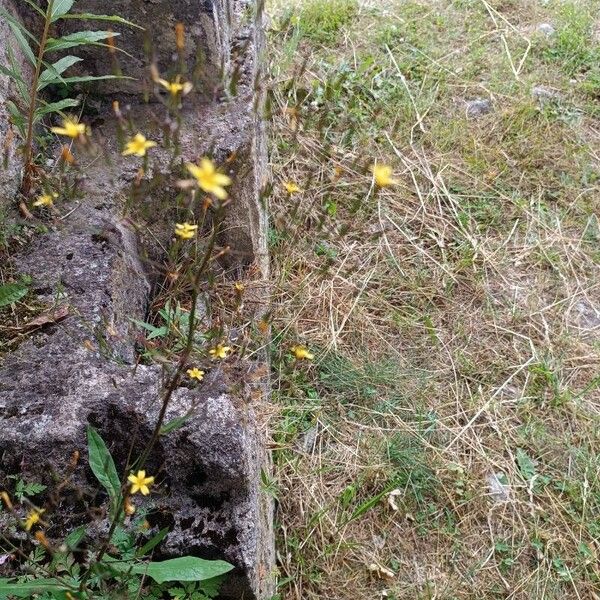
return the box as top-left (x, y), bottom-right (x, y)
top-left (131, 556), bottom-right (233, 583)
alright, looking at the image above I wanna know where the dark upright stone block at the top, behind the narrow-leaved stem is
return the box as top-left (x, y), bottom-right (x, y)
top-left (23, 0), bottom-right (239, 99)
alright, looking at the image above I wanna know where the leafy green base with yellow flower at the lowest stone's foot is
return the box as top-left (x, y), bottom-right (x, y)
top-left (0, 427), bottom-right (233, 600)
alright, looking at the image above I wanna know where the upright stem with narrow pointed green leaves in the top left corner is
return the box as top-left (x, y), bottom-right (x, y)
top-left (0, 0), bottom-right (133, 196)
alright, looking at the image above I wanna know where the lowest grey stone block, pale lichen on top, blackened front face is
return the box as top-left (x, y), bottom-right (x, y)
top-left (0, 354), bottom-right (273, 599)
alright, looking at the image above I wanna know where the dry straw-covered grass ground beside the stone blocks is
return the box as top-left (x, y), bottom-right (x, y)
top-left (271, 0), bottom-right (600, 600)
